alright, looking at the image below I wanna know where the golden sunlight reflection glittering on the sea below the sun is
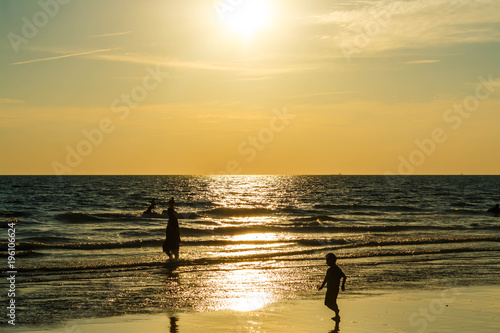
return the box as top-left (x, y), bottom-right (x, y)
top-left (199, 176), bottom-right (289, 311)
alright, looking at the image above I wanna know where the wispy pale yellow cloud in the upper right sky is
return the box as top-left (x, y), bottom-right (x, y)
top-left (304, 0), bottom-right (500, 53)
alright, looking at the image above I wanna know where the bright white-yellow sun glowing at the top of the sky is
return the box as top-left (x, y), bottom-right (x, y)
top-left (219, 0), bottom-right (272, 39)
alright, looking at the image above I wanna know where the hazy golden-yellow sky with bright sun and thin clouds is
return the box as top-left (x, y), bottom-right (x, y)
top-left (0, 0), bottom-right (500, 175)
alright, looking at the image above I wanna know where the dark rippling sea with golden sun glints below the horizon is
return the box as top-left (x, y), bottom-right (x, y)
top-left (0, 175), bottom-right (500, 327)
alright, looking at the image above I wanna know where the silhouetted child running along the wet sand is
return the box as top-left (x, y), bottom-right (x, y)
top-left (318, 253), bottom-right (347, 320)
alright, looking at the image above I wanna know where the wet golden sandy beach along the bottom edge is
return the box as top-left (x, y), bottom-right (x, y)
top-left (8, 286), bottom-right (500, 333)
